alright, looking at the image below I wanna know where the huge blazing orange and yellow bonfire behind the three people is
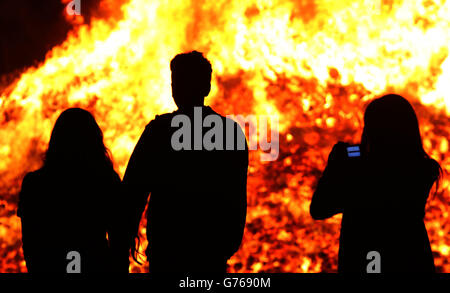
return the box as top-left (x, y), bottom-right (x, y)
top-left (0, 0), bottom-right (450, 272)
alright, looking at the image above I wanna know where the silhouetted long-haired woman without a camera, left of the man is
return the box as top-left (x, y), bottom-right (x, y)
top-left (17, 108), bottom-right (129, 273)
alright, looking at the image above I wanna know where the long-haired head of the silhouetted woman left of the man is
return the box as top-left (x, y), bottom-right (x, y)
top-left (43, 108), bottom-right (113, 174)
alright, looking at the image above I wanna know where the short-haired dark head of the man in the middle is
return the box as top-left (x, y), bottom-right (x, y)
top-left (170, 51), bottom-right (212, 109)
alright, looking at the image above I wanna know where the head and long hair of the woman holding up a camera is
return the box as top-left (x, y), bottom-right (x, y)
top-left (361, 94), bottom-right (442, 191)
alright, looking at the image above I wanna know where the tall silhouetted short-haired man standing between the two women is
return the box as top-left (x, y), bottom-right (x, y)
top-left (123, 51), bottom-right (248, 273)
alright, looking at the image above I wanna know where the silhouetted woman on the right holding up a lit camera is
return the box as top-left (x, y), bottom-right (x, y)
top-left (310, 95), bottom-right (442, 273)
